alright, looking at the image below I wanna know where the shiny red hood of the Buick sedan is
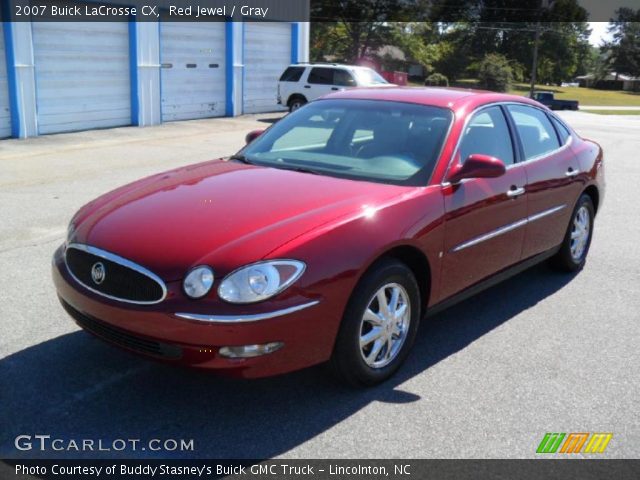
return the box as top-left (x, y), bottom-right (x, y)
top-left (70, 160), bottom-right (407, 281)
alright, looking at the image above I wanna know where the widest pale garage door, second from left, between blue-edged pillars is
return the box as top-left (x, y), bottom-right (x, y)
top-left (33, 22), bottom-right (131, 134)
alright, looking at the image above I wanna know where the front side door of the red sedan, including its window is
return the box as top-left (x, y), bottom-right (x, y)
top-left (441, 105), bottom-right (527, 300)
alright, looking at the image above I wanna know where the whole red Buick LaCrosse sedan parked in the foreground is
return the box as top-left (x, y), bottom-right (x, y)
top-left (53, 88), bottom-right (604, 385)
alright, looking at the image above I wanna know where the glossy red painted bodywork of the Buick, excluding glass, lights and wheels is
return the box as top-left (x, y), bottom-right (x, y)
top-left (53, 88), bottom-right (604, 377)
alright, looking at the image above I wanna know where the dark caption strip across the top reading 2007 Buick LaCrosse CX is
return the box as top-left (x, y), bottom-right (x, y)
top-left (1, 0), bottom-right (640, 23)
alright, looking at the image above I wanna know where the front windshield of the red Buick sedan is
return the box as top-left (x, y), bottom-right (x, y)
top-left (240, 100), bottom-right (452, 186)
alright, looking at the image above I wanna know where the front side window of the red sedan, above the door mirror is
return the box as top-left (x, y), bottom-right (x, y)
top-left (460, 107), bottom-right (514, 165)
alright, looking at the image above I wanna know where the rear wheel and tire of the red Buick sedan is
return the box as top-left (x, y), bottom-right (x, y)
top-left (552, 193), bottom-right (595, 272)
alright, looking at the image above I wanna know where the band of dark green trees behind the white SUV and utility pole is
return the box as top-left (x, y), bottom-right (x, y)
top-left (311, 0), bottom-right (593, 83)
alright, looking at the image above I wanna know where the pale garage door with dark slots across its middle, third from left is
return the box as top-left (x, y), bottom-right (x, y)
top-left (160, 22), bottom-right (226, 122)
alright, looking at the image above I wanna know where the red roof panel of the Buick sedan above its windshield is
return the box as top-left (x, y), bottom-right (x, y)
top-left (322, 87), bottom-right (540, 111)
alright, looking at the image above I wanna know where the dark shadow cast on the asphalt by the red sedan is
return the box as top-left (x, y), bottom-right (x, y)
top-left (0, 264), bottom-right (573, 459)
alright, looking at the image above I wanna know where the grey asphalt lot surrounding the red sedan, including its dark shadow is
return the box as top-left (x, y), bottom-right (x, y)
top-left (0, 112), bottom-right (640, 458)
